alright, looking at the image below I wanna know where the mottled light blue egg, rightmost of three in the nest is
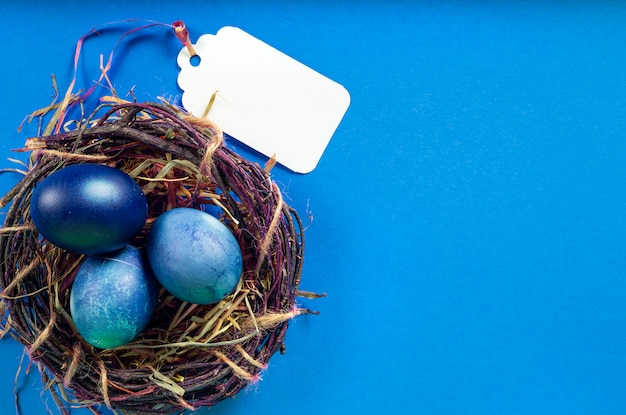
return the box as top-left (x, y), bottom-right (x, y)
top-left (146, 208), bottom-right (242, 304)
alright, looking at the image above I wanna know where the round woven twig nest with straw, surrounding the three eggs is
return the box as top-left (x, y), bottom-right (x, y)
top-left (0, 102), bottom-right (315, 414)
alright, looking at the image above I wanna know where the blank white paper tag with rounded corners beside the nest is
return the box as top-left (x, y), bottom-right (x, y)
top-left (177, 26), bottom-right (350, 173)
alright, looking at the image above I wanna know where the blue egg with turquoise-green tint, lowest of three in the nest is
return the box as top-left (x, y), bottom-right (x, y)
top-left (70, 246), bottom-right (160, 349)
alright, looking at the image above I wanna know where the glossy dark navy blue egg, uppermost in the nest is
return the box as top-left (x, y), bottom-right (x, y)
top-left (30, 164), bottom-right (148, 254)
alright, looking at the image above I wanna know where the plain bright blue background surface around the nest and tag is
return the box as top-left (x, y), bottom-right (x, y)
top-left (0, 0), bottom-right (626, 415)
